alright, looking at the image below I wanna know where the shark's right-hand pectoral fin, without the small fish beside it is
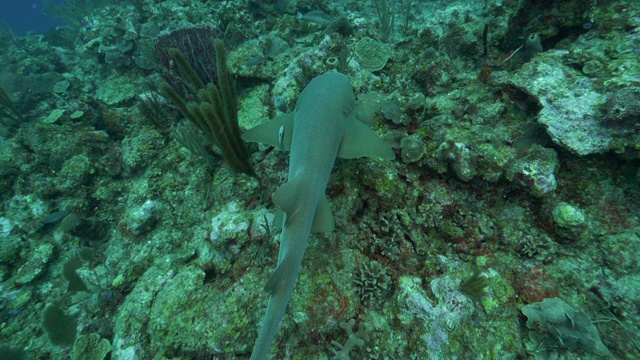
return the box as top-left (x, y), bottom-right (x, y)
top-left (338, 117), bottom-right (396, 160)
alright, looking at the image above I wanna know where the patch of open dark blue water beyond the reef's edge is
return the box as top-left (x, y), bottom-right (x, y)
top-left (0, 0), bottom-right (65, 35)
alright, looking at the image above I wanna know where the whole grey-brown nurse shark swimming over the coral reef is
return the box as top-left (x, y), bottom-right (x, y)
top-left (243, 72), bottom-right (395, 360)
